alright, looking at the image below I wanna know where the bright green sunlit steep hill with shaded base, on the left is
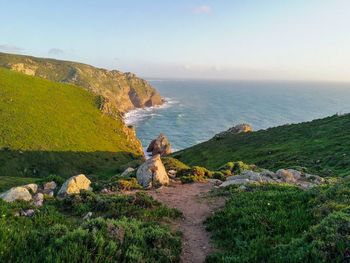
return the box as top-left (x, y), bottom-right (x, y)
top-left (0, 68), bottom-right (143, 177)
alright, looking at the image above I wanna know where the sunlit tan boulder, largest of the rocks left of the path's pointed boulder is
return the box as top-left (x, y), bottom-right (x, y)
top-left (58, 174), bottom-right (92, 196)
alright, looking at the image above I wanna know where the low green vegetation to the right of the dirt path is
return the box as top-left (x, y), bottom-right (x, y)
top-left (206, 179), bottom-right (350, 262)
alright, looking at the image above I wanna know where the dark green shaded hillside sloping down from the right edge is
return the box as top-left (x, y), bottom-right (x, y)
top-left (172, 114), bottom-right (350, 176)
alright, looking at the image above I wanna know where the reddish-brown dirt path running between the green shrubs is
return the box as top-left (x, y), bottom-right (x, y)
top-left (149, 181), bottom-right (224, 263)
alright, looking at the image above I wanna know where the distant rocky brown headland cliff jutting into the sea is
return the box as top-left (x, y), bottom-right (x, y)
top-left (0, 53), bottom-right (163, 113)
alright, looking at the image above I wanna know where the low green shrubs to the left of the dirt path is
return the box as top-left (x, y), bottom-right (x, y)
top-left (0, 191), bottom-right (181, 263)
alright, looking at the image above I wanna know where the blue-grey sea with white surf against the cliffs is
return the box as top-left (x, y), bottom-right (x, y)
top-left (126, 80), bottom-right (350, 151)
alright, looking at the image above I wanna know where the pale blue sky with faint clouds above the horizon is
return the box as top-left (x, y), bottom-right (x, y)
top-left (0, 0), bottom-right (350, 82)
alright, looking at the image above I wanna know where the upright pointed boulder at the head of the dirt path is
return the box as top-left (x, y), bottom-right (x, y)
top-left (136, 154), bottom-right (169, 188)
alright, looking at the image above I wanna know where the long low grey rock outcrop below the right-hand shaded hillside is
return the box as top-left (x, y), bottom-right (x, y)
top-left (220, 169), bottom-right (325, 189)
